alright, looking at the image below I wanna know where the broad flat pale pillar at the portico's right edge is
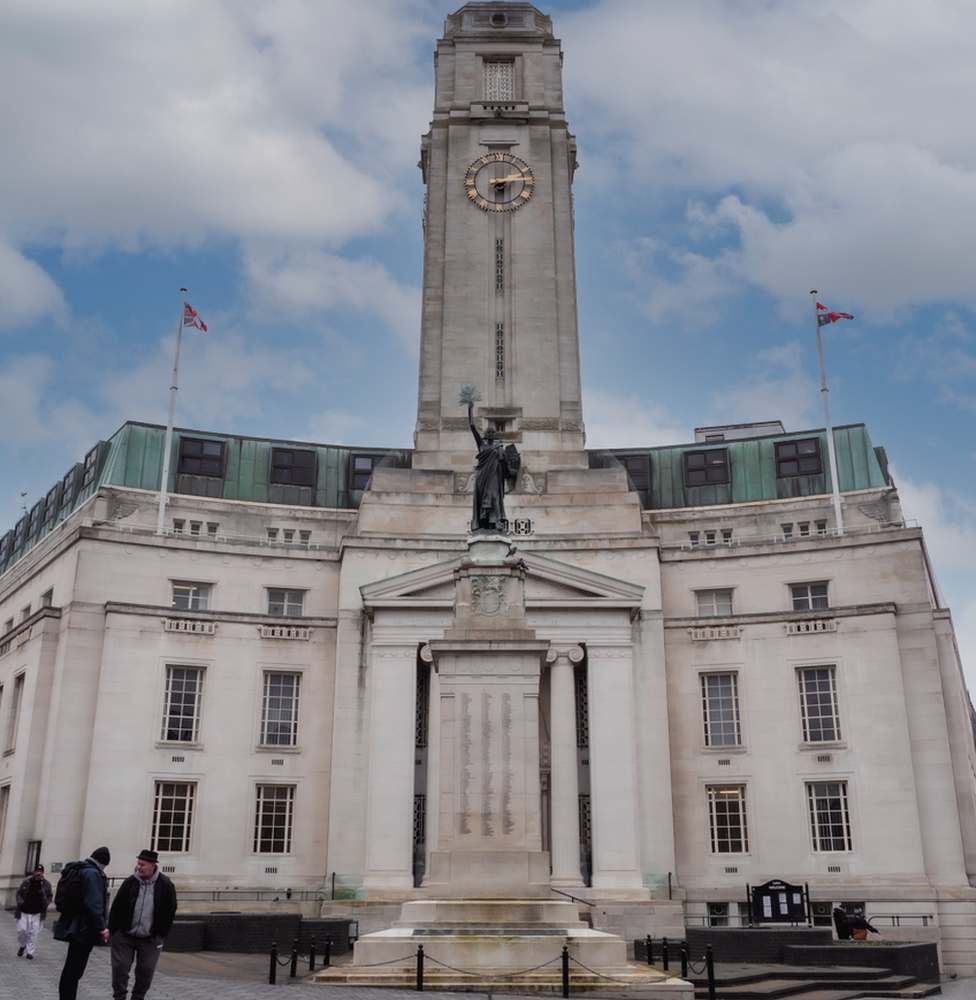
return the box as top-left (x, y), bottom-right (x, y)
top-left (587, 644), bottom-right (649, 898)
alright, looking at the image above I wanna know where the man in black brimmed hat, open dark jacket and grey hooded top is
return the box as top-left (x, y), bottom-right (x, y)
top-left (108, 851), bottom-right (176, 1000)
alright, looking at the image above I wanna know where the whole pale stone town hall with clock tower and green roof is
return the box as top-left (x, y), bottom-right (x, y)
top-left (0, 0), bottom-right (976, 975)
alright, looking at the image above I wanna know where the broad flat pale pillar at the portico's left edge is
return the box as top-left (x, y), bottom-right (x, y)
top-left (362, 641), bottom-right (417, 889)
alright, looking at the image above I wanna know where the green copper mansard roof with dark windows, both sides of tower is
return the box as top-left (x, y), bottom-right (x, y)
top-left (0, 423), bottom-right (891, 573)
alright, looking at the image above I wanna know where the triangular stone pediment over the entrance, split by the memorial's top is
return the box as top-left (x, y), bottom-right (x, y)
top-left (360, 553), bottom-right (644, 608)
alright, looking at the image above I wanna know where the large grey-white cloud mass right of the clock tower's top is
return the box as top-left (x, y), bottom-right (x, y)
top-left (561, 0), bottom-right (976, 322)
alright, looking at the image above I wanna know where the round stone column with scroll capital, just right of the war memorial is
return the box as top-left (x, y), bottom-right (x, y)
top-left (546, 646), bottom-right (583, 887)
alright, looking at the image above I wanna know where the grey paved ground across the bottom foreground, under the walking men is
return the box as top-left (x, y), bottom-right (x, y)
top-left (0, 911), bottom-right (976, 1000)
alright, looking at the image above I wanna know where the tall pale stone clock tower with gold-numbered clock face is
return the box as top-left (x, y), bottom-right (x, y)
top-left (414, 2), bottom-right (586, 473)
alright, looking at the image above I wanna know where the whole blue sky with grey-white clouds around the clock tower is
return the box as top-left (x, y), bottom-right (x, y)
top-left (0, 0), bottom-right (976, 688)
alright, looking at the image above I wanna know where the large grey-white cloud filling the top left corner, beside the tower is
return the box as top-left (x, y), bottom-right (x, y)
top-left (0, 0), bottom-right (432, 250)
